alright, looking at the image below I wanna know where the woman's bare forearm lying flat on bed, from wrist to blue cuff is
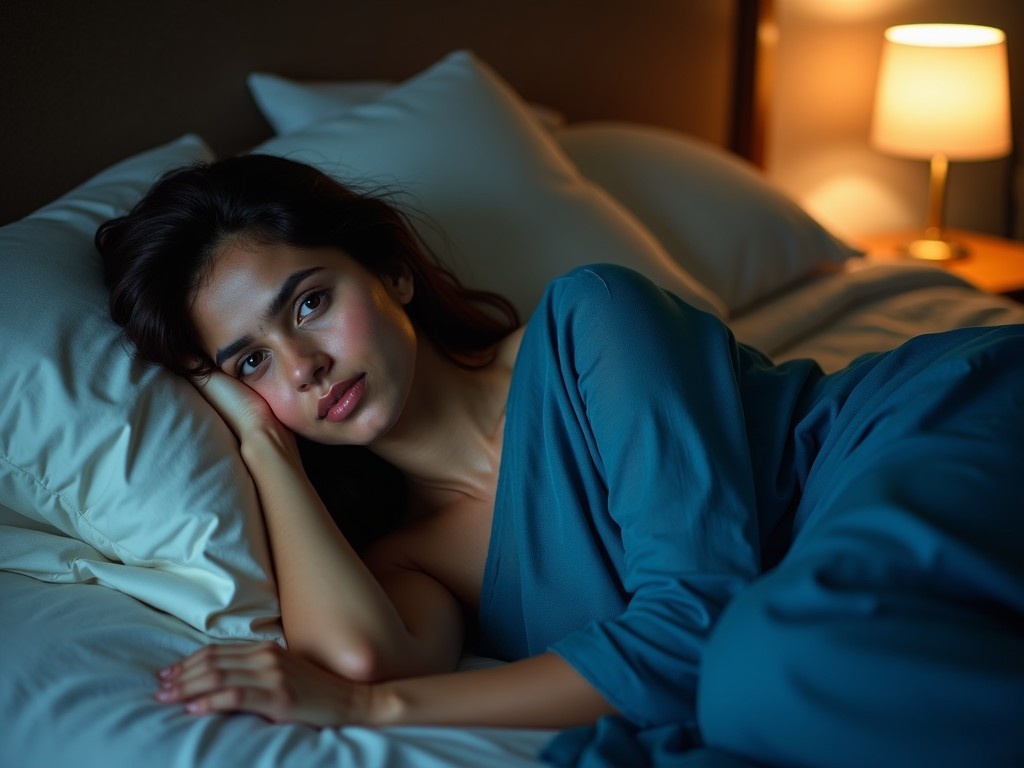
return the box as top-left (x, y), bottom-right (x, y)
top-left (371, 653), bottom-right (615, 728)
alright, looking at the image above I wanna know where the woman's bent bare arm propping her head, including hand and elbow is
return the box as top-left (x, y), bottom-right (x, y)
top-left (194, 374), bottom-right (462, 682)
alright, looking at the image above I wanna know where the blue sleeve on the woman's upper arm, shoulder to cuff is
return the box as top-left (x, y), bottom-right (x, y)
top-left (531, 265), bottom-right (759, 726)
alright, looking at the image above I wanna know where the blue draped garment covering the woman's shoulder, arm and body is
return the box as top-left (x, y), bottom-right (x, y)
top-left (479, 265), bottom-right (1024, 767)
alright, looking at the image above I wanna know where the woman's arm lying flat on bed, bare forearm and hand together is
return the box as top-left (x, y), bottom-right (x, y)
top-left (157, 643), bottom-right (614, 728)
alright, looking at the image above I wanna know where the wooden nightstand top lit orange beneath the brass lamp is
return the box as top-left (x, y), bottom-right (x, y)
top-left (852, 229), bottom-right (1024, 301)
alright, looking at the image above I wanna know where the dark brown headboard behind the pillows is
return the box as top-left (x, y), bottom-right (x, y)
top-left (0, 0), bottom-right (769, 224)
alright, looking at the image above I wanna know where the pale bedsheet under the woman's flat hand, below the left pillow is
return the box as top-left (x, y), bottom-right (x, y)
top-left (0, 572), bottom-right (551, 768)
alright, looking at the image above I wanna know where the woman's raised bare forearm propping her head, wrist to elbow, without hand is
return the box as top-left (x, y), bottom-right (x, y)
top-left (242, 433), bottom-right (459, 681)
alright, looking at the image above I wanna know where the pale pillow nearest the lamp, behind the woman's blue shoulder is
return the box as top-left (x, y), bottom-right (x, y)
top-left (554, 123), bottom-right (858, 314)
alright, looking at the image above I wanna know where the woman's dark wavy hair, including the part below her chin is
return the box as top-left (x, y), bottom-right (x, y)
top-left (95, 155), bottom-right (519, 546)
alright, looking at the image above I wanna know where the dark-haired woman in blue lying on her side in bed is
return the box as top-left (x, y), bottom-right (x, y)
top-left (97, 156), bottom-right (1024, 765)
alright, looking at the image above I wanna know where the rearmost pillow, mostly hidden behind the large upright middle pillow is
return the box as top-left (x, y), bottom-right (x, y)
top-left (247, 72), bottom-right (565, 133)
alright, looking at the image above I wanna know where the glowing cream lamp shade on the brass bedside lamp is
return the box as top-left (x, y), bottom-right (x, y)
top-left (871, 24), bottom-right (1011, 160)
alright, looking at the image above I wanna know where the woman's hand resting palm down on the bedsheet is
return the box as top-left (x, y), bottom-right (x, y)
top-left (157, 642), bottom-right (382, 726)
